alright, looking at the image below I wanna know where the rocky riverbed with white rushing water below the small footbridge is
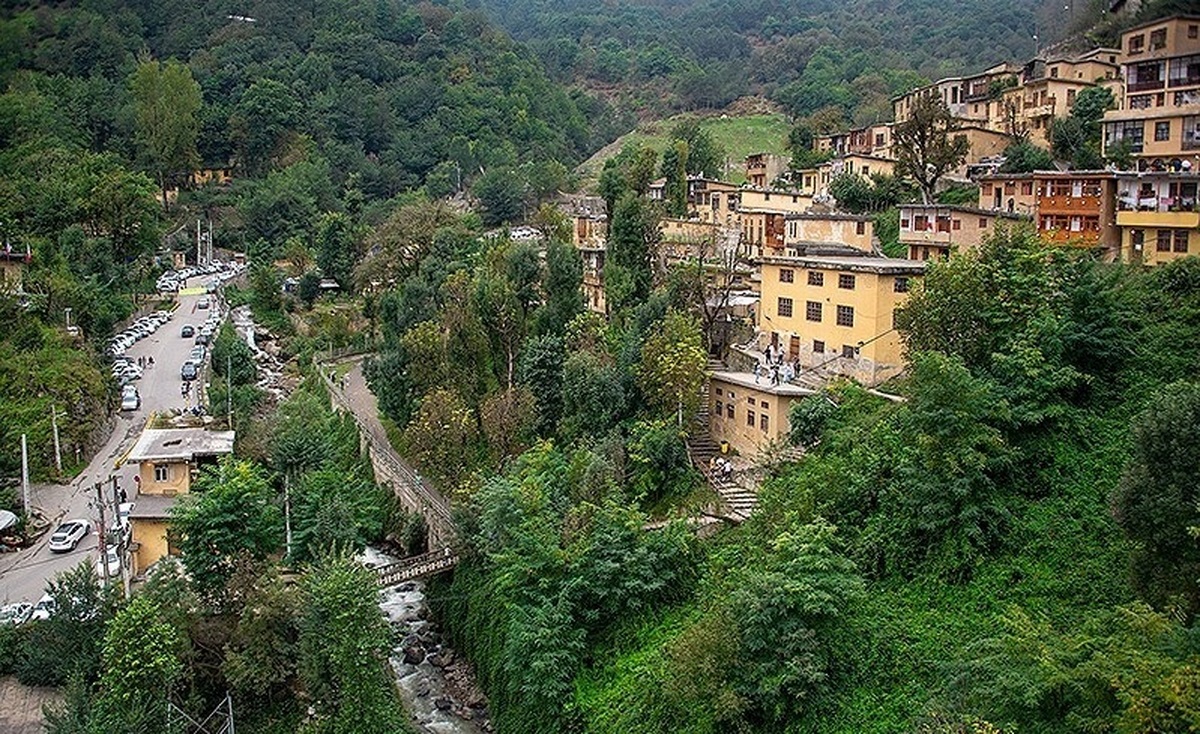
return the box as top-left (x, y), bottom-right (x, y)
top-left (379, 582), bottom-right (493, 734)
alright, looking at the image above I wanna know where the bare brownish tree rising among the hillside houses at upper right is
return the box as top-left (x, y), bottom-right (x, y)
top-left (892, 95), bottom-right (971, 204)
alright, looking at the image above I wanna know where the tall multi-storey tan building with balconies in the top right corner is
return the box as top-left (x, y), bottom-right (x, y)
top-left (1104, 16), bottom-right (1200, 170)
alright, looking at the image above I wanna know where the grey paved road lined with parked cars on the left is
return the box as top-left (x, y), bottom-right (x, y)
top-left (0, 278), bottom-right (218, 603)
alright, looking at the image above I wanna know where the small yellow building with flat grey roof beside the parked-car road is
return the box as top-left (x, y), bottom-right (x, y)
top-left (125, 428), bottom-right (234, 574)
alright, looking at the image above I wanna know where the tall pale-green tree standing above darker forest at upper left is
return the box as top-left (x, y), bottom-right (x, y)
top-left (132, 59), bottom-right (200, 211)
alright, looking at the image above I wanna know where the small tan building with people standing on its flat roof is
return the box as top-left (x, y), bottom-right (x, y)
top-left (708, 372), bottom-right (814, 456)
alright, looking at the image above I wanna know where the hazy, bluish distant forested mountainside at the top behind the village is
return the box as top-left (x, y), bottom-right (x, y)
top-left (468, 0), bottom-right (1060, 122)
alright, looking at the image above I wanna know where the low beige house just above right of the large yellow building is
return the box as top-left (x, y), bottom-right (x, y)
top-left (900, 204), bottom-right (1031, 260)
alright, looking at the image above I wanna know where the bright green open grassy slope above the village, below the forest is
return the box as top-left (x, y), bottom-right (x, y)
top-left (576, 112), bottom-right (791, 188)
